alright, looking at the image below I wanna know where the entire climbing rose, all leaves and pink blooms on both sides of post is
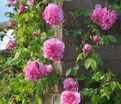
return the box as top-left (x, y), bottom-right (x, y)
top-left (0, 0), bottom-right (121, 104)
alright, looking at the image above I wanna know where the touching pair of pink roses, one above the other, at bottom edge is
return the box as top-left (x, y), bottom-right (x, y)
top-left (60, 78), bottom-right (81, 104)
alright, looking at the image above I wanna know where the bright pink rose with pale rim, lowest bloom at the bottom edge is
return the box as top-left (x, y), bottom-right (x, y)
top-left (60, 91), bottom-right (81, 104)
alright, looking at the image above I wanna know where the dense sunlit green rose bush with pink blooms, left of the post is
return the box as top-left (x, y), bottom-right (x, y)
top-left (0, 0), bottom-right (65, 104)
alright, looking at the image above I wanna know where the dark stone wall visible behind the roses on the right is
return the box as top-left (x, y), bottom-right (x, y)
top-left (62, 0), bottom-right (121, 73)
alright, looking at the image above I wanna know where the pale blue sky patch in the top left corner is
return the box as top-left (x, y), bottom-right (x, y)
top-left (0, 0), bottom-right (12, 23)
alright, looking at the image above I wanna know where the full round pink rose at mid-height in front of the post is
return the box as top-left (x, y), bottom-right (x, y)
top-left (42, 38), bottom-right (65, 61)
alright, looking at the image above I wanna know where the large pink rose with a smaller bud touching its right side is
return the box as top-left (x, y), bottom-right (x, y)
top-left (24, 60), bottom-right (52, 82)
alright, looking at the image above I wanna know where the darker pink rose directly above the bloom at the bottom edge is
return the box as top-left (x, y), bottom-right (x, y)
top-left (63, 78), bottom-right (78, 91)
